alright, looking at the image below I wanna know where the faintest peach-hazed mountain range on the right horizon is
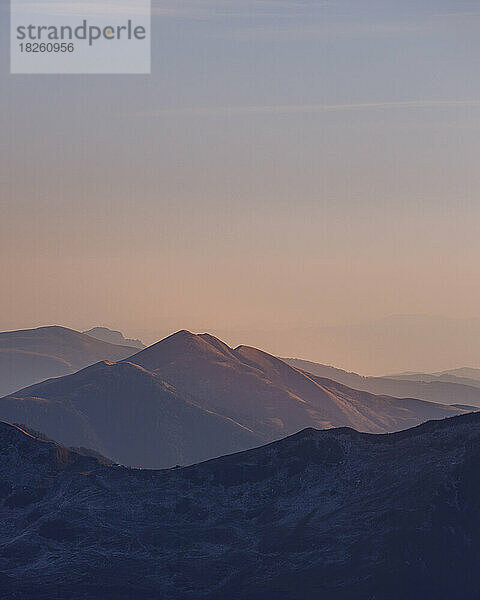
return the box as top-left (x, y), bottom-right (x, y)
top-left (276, 315), bottom-right (480, 374)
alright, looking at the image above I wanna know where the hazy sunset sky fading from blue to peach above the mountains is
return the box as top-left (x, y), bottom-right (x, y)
top-left (0, 0), bottom-right (480, 372)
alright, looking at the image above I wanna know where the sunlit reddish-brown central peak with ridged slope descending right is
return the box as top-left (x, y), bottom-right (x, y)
top-left (130, 331), bottom-right (466, 439)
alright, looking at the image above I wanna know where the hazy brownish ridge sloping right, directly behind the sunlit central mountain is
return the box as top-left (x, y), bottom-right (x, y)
top-left (282, 358), bottom-right (480, 408)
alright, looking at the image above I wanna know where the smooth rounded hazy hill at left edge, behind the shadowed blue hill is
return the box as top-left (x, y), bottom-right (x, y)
top-left (0, 327), bottom-right (138, 396)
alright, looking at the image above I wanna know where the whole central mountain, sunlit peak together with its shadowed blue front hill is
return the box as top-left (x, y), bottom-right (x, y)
top-left (0, 331), bottom-right (466, 467)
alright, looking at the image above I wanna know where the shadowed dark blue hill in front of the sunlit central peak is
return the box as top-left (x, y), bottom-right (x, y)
top-left (0, 362), bottom-right (262, 467)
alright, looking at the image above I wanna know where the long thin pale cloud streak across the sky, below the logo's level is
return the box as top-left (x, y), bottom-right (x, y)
top-left (144, 99), bottom-right (480, 117)
